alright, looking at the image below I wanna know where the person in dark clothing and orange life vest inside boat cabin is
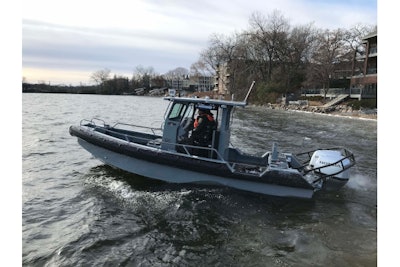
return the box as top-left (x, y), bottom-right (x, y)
top-left (191, 109), bottom-right (217, 149)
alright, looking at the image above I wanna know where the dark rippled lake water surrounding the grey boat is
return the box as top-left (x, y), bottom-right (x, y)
top-left (22, 94), bottom-right (377, 267)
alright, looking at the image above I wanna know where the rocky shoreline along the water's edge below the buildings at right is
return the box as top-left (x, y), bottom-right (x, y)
top-left (258, 103), bottom-right (378, 120)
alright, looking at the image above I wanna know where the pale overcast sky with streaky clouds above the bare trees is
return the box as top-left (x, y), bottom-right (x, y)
top-left (22, 0), bottom-right (377, 85)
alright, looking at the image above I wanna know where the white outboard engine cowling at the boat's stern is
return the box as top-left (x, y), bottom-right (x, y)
top-left (309, 150), bottom-right (351, 182)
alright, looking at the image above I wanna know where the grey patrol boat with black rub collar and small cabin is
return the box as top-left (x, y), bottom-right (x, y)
top-left (69, 91), bottom-right (355, 198)
